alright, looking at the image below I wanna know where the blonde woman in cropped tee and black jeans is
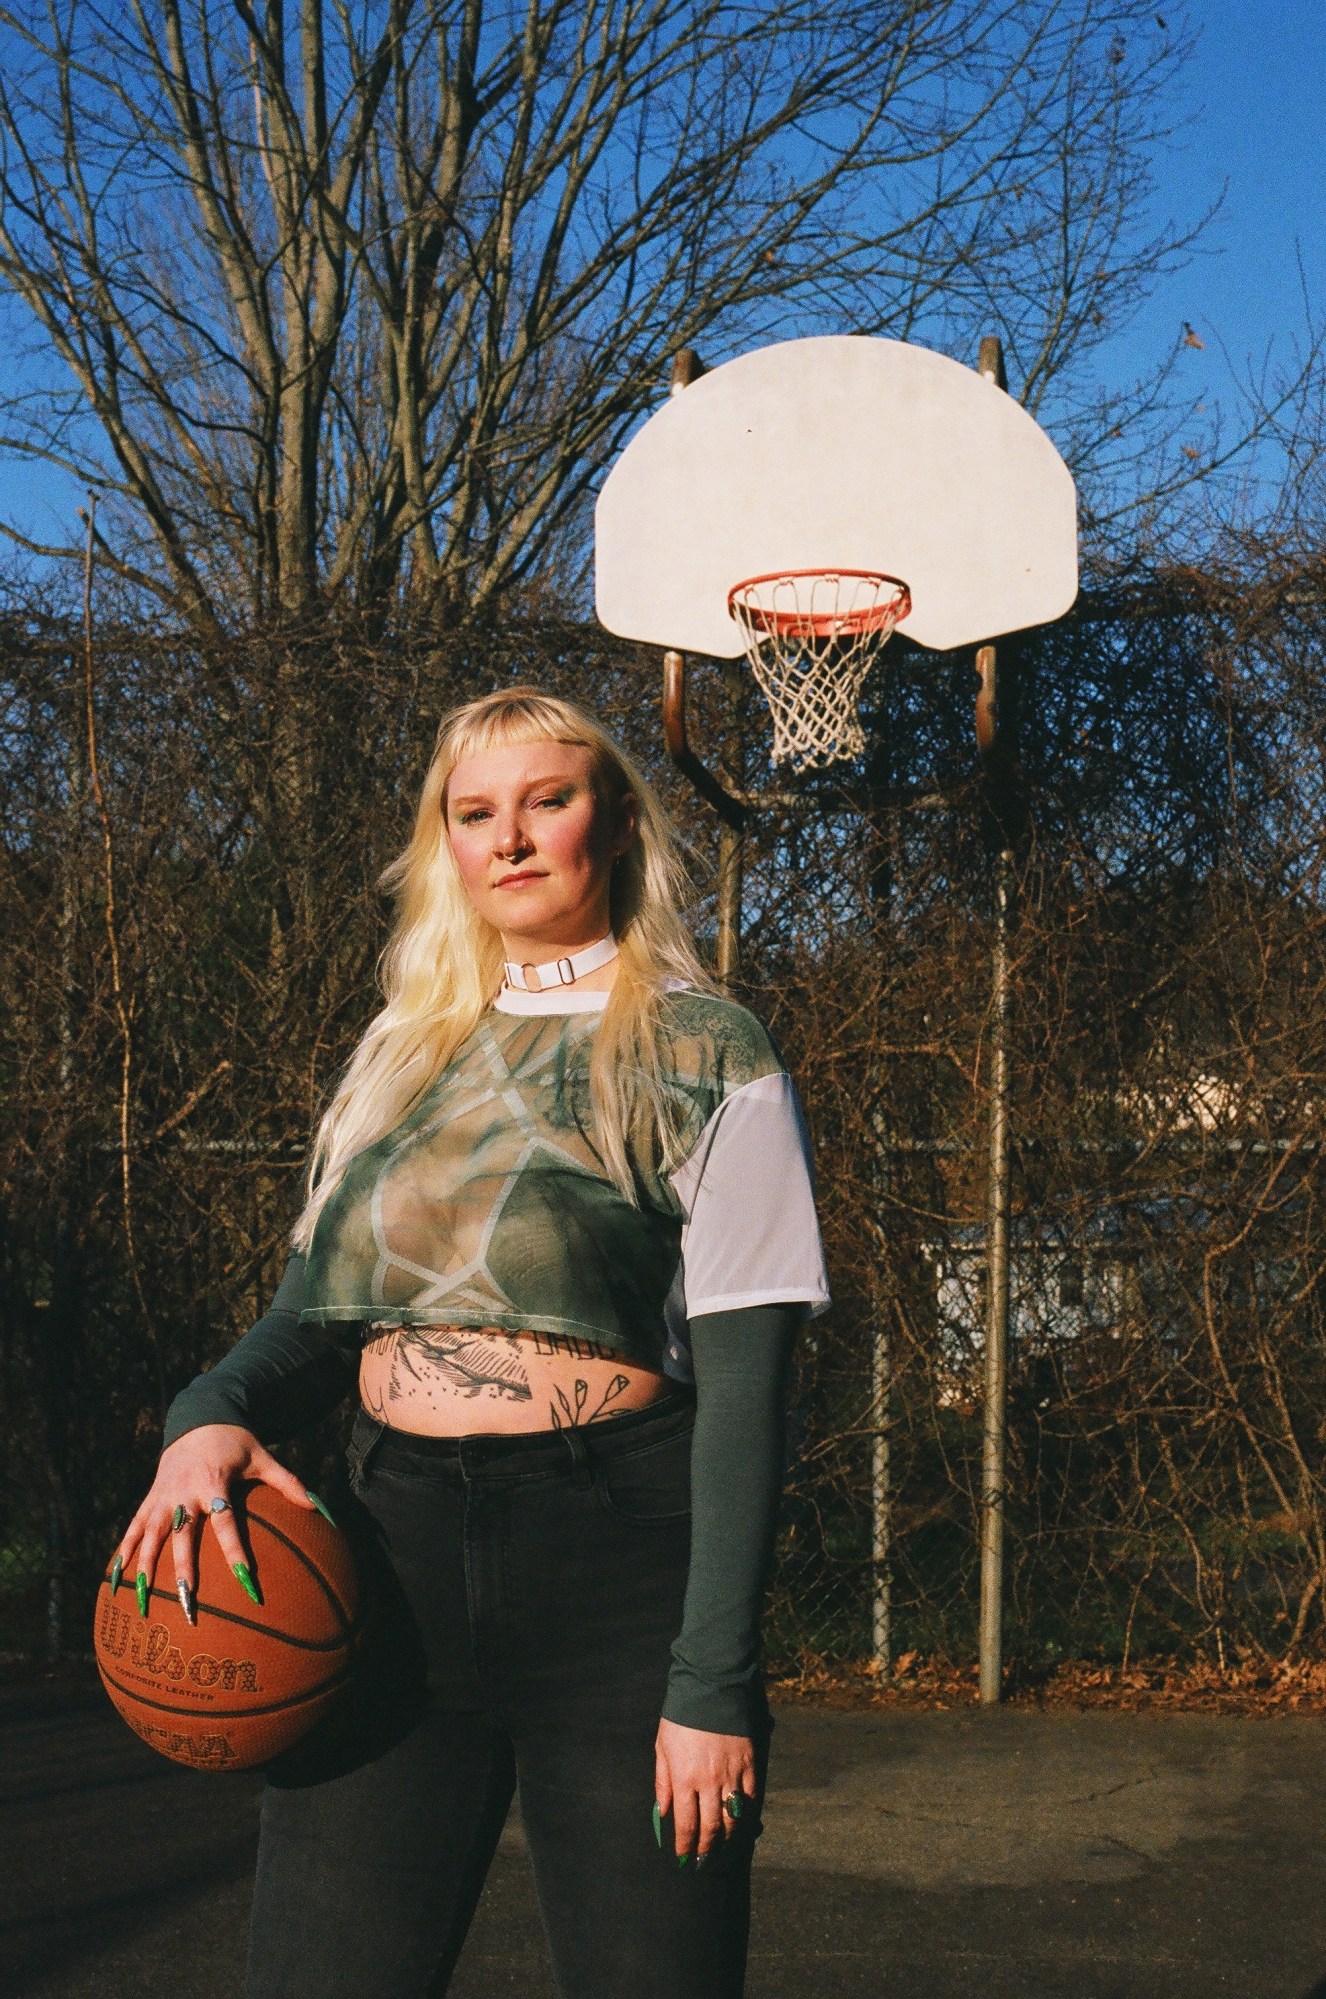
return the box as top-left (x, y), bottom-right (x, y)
top-left (120, 690), bottom-right (828, 1999)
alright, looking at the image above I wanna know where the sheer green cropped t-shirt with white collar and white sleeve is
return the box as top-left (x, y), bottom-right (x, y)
top-left (300, 988), bottom-right (828, 1381)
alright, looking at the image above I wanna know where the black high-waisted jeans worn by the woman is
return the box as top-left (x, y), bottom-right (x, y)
top-left (248, 1395), bottom-right (772, 1999)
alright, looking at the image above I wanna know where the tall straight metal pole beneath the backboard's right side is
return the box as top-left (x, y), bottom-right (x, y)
top-left (980, 848), bottom-right (1014, 1707)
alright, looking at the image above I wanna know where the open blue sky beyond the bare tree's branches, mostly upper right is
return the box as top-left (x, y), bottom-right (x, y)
top-left (0, 0), bottom-right (1326, 563)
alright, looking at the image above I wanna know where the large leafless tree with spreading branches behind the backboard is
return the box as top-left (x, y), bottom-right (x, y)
top-left (0, 0), bottom-right (1186, 632)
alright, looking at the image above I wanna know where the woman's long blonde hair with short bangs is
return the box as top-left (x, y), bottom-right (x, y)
top-left (292, 688), bottom-right (718, 1249)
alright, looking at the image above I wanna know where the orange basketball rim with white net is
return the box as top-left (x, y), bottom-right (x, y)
top-left (728, 570), bottom-right (912, 770)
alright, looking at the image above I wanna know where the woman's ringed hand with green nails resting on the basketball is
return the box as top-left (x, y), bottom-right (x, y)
top-left (114, 1423), bottom-right (314, 1623)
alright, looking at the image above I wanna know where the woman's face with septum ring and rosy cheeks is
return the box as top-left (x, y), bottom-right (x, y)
top-left (446, 742), bottom-right (636, 958)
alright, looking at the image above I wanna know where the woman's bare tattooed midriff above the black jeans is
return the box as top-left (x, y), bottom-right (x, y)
top-left (360, 1321), bottom-right (668, 1437)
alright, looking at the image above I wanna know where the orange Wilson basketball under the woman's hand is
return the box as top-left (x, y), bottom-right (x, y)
top-left (94, 1483), bottom-right (358, 1769)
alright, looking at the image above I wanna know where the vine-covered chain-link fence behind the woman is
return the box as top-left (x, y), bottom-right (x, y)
top-left (0, 578), bottom-right (1326, 1677)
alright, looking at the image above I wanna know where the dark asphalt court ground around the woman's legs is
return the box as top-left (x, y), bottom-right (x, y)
top-left (0, 1685), bottom-right (1326, 1999)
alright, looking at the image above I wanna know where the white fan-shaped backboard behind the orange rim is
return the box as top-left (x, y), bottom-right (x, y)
top-left (594, 334), bottom-right (1078, 660)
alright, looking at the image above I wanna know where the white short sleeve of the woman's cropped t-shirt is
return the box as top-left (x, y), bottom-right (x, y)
top-left (668, 1073), bottom-right (830, 1319)
